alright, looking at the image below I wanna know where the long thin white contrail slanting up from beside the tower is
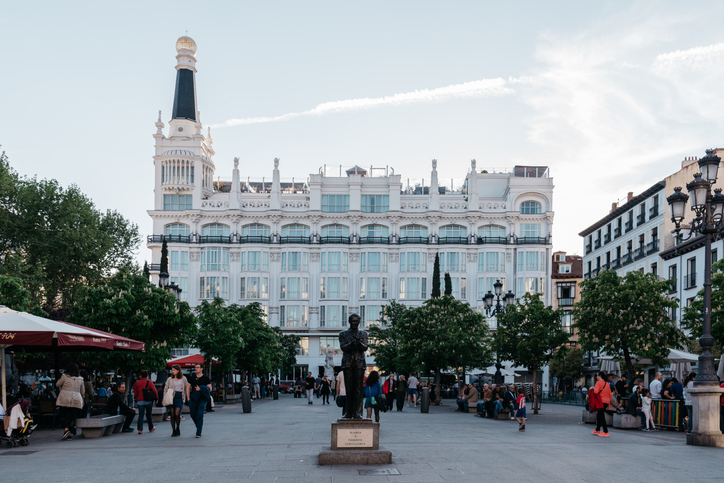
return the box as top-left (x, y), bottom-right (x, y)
top-left (212, 78), bottom-right (519, 128)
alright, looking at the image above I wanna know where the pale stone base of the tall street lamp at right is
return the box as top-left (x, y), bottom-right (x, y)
top-left (686, 386), bottom-right (724, 448)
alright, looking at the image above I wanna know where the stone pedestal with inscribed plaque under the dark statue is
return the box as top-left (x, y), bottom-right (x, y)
top-left (319, 419), bottom-right (392, 465)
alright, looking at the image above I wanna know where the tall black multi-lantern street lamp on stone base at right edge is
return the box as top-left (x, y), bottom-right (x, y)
top-left (666, 149), bottom-right (724, 447)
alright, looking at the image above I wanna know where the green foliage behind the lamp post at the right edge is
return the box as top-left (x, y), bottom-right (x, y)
top-left (681, 259), bottom-right (724, 351)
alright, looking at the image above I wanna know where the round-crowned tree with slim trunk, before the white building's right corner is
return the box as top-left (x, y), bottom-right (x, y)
top-left (495, 293), bottom-right (568, 414)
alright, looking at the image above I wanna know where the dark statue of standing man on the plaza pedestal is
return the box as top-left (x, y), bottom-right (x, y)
top-left (339, 314), bottom-right (368, 419)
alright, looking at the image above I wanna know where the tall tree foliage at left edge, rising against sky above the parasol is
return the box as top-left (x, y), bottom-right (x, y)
top-left (0, 153), bottom-right (140, 319)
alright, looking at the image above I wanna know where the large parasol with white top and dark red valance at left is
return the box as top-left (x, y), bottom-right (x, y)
top-left (0, 306), bottom-right (145, 407)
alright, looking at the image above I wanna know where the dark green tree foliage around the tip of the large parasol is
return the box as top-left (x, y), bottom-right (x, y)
top-left (69, 271), bottom-right (196, 371)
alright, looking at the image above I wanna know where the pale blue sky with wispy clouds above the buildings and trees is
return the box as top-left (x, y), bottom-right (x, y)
top-left (0, 0), bottom-right (724, 262)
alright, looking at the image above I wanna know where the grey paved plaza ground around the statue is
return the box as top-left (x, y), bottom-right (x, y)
top-left (0, 395), bottom-right (724, 483)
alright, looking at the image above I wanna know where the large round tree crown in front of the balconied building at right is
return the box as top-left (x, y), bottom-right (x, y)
top-left (572, 270), bottom-right (686, 376)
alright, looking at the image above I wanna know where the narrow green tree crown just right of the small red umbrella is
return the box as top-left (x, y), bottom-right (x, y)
top-left (193, 297), bottom-right (251, 373)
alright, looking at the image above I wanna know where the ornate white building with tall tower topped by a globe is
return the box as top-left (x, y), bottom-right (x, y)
top-left (148, 37), bottom-right (553, 373)
